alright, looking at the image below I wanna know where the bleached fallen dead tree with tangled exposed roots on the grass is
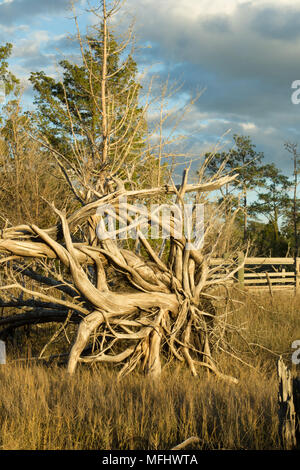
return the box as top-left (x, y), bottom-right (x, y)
top-left (0, 165), bottom-right (243, 382)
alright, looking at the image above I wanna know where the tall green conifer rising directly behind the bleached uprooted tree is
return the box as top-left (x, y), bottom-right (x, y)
top-left (30, 24), bottom-right (146, 195)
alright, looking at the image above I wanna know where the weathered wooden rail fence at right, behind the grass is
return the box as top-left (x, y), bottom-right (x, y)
top-left (211, 253), bottom-right (300, 291)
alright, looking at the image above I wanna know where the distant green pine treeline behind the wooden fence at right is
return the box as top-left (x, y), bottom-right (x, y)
top-left (206, 134), bottom-right (300, 257)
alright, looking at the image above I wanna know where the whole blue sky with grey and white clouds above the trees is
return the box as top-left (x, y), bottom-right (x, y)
top-left (0, 0), bottom-right (300, 174)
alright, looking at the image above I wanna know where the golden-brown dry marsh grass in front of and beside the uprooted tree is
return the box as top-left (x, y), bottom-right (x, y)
top-left (0, 288), bottom-right (300, 450)
